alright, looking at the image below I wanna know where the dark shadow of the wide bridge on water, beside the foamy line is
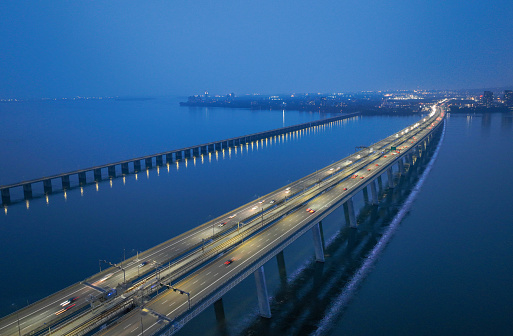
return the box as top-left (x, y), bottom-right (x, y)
top-left (232, 131), bottom-right (439, 335)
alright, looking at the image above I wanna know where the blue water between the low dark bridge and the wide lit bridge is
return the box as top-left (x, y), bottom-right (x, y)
top-left (0, 101), bottom-right (424, 322)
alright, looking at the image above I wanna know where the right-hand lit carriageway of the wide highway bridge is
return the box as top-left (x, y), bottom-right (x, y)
top-left (96, 106), bottom-right (444, 335)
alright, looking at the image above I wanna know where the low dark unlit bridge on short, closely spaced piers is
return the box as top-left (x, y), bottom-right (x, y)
top-left (0, 113), bottom-right (359, 206)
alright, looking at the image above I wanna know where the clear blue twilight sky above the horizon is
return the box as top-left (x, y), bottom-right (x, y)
top-left (0, 0), bottom-right (513, 98)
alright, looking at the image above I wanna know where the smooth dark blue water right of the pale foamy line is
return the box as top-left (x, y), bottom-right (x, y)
top-left (329, 114), bottom-right (513, 335)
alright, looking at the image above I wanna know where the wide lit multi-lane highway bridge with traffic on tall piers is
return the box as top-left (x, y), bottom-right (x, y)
top-left (0, 103), bottom-right (444, 335)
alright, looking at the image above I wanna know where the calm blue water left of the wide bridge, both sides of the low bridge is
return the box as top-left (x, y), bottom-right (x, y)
top-left (0, 98), bottom-right (418, 315)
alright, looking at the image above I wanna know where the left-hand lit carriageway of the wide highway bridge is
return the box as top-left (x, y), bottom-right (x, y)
top-left (0, 109), bottom-right (440, 335)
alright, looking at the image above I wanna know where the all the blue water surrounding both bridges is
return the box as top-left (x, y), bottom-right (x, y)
top-left (0, 98), bottom-right (513, 335)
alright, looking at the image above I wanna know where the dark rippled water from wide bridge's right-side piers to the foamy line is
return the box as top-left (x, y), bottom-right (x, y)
top-left (181, 122), bottom-right (438, 336)
